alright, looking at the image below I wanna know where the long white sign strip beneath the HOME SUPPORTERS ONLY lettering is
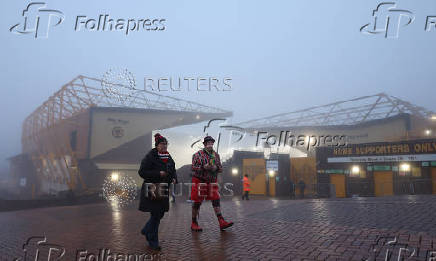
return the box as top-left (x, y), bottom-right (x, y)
top-left (327, 154), bottom-right (436, 163)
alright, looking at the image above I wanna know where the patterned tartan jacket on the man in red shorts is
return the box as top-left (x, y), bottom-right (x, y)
top-left (191, 147), bottom-right (223, 182)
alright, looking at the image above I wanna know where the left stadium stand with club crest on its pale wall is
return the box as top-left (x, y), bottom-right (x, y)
top-left (10, 76), bottom-right (232, 198)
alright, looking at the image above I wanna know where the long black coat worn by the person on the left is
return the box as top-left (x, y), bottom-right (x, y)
top-left (138, 148), bottom-right (177, 212)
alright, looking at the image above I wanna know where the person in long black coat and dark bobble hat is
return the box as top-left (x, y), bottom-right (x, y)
top-left (138, 133), bottom-right (177, 250)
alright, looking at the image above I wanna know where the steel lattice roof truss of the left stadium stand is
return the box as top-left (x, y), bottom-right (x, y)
top-left (23, 75), bottom-right (230, 139)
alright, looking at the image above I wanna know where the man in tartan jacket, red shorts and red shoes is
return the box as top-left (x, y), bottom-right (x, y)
top-left (191, 136), bottom-right (233, 231)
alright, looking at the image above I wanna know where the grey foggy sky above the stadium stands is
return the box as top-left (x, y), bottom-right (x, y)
top-left (0, 0), bottom-right (436, 173)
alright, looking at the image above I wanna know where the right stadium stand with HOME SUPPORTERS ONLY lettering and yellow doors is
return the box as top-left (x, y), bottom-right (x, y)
top-left (226, 93), bottom-right (436, 197)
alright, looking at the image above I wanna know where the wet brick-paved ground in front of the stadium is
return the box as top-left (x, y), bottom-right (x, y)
top-left (0, 195), bottom-right (436, 261)
